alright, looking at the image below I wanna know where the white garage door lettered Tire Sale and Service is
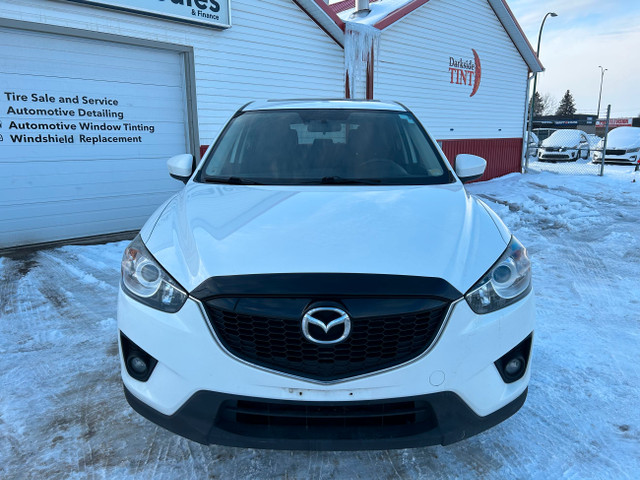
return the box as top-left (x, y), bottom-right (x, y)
top-left (0, 28), bottom-right (192, 248)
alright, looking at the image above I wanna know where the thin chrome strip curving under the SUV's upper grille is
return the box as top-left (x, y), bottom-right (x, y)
top-left (189, 295), bottom-right (465, 385)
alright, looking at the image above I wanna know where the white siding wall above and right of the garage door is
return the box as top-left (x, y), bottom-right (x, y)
top-left (0, 0), bottom-right (344, 144)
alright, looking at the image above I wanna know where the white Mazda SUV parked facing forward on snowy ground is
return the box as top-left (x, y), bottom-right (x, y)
top-left (118, 100), bottom-right (534, 450)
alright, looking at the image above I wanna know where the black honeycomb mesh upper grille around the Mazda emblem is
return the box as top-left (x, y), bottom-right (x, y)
top-left (204, 298), bottom-right (449, 381)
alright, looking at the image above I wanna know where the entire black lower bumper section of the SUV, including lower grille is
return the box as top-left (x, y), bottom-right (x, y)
top-left (124, 387), bottom-right (527, 450)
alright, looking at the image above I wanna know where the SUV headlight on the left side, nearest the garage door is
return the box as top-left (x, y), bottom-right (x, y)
top-left (122, 235), bottom-right (187, 313)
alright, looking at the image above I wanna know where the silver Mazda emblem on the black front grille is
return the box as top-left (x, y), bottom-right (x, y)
top-left (302, 307), bottom-right (351, 345)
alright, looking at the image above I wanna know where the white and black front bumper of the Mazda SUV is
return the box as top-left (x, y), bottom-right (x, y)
top-left (118, 286), bottom-right (535, 449)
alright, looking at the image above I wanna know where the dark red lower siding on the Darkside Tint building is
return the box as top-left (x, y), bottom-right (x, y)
top-left (439, 138), bottom-right (522, 181)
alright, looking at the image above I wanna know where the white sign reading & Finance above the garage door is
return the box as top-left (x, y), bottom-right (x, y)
top-left (62, 0), bottom-right (231, 28)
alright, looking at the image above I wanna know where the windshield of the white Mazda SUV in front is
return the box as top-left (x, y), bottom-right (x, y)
top-left (198, 109), bottom-right (452, 185)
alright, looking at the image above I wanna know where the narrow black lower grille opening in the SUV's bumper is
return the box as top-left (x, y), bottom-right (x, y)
top-left (216, 400), bottom-right (438, 440)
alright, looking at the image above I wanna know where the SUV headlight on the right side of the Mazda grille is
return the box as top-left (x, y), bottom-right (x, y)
top-left (465, 237), bottom-right (531, 313)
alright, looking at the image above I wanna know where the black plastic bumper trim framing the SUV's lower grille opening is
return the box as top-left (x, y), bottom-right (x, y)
top-left (124, 387), bottom-right (528, 451)
